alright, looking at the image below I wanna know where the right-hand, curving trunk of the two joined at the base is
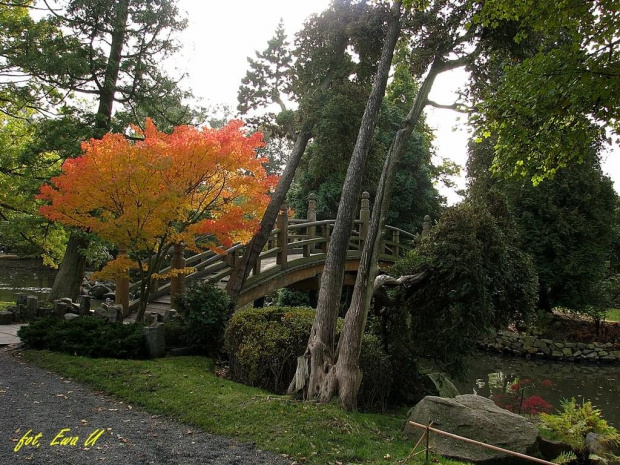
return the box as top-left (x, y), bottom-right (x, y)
top-left (330, 61), bottom-right (450, 410)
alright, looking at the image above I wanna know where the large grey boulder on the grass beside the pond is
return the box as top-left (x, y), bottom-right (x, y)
top-left (404, 394), bottom-right (538, 465)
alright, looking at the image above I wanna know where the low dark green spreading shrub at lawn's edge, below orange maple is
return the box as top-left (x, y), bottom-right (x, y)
top-left (18, 317), bottom-right (147, 359)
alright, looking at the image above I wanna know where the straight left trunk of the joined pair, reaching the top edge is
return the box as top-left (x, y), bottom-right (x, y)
top-left (289, 2), bottom-right (401, 400)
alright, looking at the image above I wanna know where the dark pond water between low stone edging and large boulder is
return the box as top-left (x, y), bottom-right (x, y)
top-left (454, 353), bottom-right (620, 428)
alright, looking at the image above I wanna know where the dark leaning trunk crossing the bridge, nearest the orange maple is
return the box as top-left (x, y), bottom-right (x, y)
top-left (226, 24), bottom-right (347, 302)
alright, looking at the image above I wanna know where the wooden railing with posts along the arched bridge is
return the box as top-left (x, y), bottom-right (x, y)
top-left (116, 192), bottom-right (422, 310)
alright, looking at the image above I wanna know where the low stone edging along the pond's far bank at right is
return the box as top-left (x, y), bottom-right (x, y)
top-left (478, 331), bottom-right (620, 363)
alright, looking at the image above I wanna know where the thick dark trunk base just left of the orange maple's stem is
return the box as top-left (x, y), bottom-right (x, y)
top-left (48, 232), bottom-right (88, 302)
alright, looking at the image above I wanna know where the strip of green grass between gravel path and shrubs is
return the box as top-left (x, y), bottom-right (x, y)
top-left (23, 351), bottom-right (458, 465)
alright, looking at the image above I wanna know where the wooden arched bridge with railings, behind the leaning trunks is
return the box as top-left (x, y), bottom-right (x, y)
top-left (116, 192), bottom-right (427, 312)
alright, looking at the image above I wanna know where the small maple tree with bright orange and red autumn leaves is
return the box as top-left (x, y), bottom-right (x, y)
top-left (39, 119), bottom-right (277, 320)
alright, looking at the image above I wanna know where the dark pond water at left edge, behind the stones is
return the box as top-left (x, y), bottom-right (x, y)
top-left (0, 260), bottom-right (56, 302)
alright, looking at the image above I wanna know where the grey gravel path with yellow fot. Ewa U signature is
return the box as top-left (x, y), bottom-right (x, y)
top-left (0, 349), bottom-right (290, 465)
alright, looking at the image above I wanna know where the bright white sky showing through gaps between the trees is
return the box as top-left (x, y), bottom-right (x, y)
top-left (172, 0), bottom-right (620, 204)
